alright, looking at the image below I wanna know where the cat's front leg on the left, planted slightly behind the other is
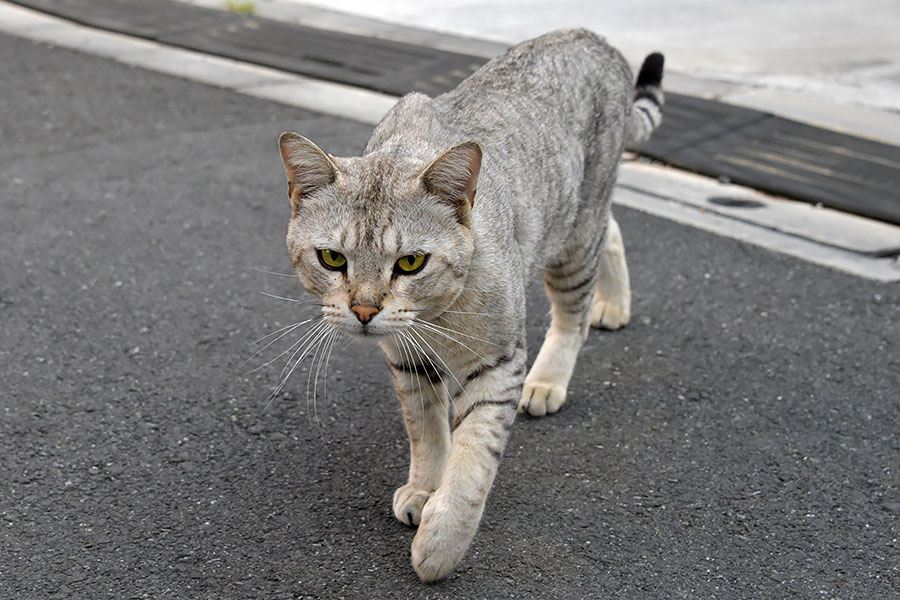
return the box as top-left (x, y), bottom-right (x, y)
top-left (384, 345), bottom-right (450, 526)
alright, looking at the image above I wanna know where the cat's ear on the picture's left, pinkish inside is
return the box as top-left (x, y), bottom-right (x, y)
top-left (278, 131), bottom-right (337, 217)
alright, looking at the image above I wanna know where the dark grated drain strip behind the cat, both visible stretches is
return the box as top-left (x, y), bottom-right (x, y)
top-left (13, 0), bottom-right (900, 224)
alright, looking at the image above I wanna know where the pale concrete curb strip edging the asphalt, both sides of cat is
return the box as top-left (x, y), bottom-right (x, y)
top-left (0, 0), bottom-right (900, 281)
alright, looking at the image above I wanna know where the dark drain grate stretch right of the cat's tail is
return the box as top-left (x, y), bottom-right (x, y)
top-left (641, 94), bottom-right (900, 223)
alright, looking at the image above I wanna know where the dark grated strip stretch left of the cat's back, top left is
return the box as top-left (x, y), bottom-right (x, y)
top-left (7, 0), bottom-right (486, 96)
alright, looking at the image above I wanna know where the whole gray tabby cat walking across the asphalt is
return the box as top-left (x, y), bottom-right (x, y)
top-left (279, 29), bottom-right (663, 581)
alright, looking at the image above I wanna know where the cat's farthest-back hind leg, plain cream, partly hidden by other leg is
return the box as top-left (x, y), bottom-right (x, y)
top-left (591, 215), bottom-right (631, 329)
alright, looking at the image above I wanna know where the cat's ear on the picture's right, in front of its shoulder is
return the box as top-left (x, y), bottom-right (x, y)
top-left (422, 141), bottom-right (481, 223)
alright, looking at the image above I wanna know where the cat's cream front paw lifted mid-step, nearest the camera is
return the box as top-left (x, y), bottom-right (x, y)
top-left (412, 497), bottom-right (481, 582)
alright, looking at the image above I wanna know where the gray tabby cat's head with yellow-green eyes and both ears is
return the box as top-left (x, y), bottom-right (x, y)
top-left (279, 132), bottom-right (481, 336)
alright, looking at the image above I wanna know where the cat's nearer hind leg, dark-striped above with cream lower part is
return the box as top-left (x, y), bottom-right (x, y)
top-left (519, 232), bottom-right (602, 417)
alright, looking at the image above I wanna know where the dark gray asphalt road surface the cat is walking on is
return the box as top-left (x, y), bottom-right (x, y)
top-left (0, 36), bottom-right (900, 600)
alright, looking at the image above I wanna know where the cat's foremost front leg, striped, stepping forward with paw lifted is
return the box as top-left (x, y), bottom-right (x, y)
top-left (412, 344), bottom-right (525, 581)
